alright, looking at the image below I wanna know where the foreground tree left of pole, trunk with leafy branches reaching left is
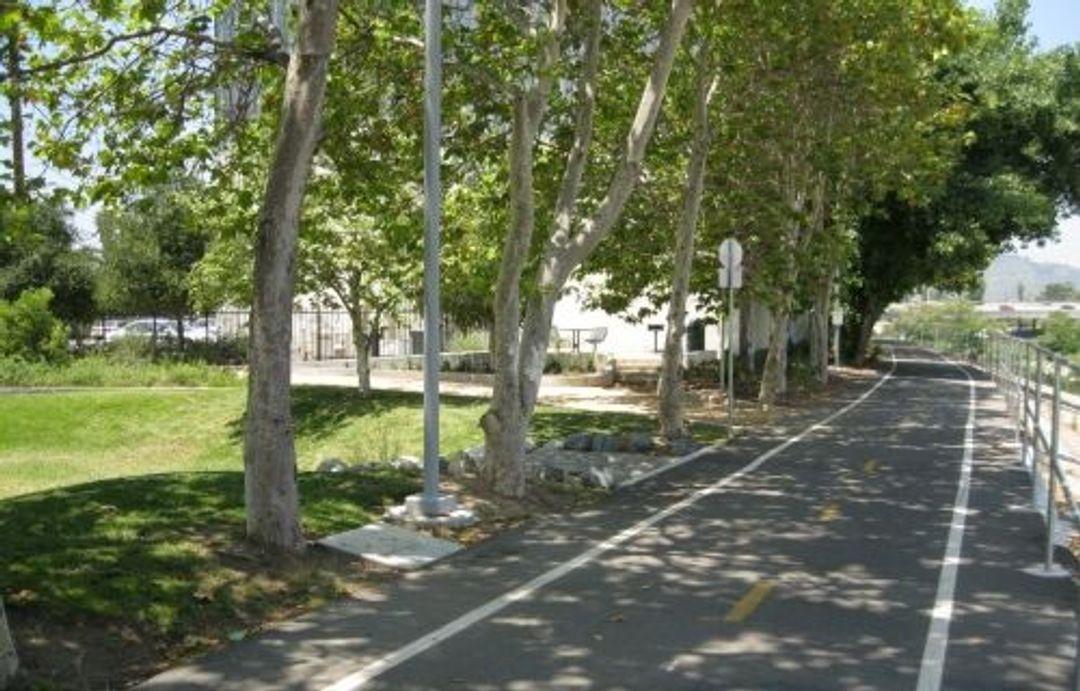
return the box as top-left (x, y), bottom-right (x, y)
top-left (0, 0), bottom-right (337, 552)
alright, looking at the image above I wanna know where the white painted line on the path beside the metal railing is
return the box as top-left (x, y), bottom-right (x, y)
top-left (915, 360), bottom-right (976, 691)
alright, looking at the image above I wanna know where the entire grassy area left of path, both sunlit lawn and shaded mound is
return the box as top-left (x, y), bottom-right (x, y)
top-left (0, 387), bottom-right (704, 688)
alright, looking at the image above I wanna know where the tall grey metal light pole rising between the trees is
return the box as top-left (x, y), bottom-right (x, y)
top-left (421, 0), bottom-right (443, 514)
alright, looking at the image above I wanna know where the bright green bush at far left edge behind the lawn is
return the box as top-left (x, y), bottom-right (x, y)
top-left (0, 288), bottom-right (68, 363)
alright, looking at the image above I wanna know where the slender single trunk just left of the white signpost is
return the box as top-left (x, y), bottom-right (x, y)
top-left (657, 58), bottom-right (724, 439)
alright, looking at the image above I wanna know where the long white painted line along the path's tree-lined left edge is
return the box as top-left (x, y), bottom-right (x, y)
top-left (322, 360), bottom-right (896, 691)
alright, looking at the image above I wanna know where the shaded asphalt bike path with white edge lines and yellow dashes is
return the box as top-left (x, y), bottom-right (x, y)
top-left (144, 349), bottom-right (1077, 691)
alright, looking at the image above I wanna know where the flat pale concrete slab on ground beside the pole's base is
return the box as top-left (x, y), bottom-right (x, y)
top-left (319, 523), bottom-right (461, 571)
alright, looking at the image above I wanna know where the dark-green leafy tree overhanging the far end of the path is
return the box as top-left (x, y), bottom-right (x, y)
top-left (845, 0), bottom-right (1080, 363)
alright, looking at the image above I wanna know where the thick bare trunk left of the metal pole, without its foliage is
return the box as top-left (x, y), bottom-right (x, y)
top-left (244, 0), bottom-right (337, 553)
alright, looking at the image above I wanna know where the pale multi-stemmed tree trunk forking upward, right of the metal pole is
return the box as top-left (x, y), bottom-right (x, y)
top-left (481, 0), bottom-right (693, 497)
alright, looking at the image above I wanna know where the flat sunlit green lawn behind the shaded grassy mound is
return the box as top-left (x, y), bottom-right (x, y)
top-left (0, 387), bottom-right (699, 500)
